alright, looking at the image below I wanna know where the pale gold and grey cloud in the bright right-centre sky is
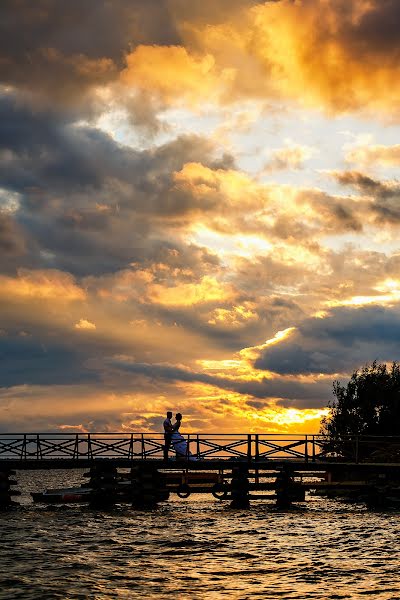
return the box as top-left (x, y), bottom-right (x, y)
top-left (173, 163), bottom-right (362, 245)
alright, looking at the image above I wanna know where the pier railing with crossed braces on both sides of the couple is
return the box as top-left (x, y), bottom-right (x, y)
top-left (0, 433), bottom-right (400, 463)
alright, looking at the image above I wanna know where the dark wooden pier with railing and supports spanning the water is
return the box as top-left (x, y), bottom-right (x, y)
top-left (0, 433), bottom-right (400, 508)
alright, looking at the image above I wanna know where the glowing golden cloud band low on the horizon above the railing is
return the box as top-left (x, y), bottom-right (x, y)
top-left (0, 383), bottom-right (327, 435)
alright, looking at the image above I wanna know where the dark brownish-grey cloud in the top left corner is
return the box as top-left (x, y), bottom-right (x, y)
top-left (0, 0), bottom-right (180, 105)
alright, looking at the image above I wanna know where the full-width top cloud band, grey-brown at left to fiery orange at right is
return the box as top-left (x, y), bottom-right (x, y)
top-left (0, 0), bottom-right (400, 120)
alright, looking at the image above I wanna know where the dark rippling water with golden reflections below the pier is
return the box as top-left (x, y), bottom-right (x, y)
top-left (0, 471), bottom-right (400, 600)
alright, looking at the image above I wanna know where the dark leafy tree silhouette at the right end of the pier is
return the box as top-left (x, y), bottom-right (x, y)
top-left (321, 361), bottom-right (400, 449)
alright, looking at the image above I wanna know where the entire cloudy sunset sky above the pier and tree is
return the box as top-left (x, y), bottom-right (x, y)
top-left (0, 0), bottom-right (400, 433)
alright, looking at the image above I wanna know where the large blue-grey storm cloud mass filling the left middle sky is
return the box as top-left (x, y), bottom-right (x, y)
top-left (0, 94), bottom-right (232, 275)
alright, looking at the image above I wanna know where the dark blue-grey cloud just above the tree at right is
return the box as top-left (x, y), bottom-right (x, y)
top-left (254, 306), bottom-right (400, 375)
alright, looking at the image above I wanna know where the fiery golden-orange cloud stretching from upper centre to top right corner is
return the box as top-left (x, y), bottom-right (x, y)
top-left (121, 0), bottom-right (400, 117)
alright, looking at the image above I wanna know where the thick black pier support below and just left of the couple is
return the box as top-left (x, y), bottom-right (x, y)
top-left (131, 464), bottom-right (169, 508)
